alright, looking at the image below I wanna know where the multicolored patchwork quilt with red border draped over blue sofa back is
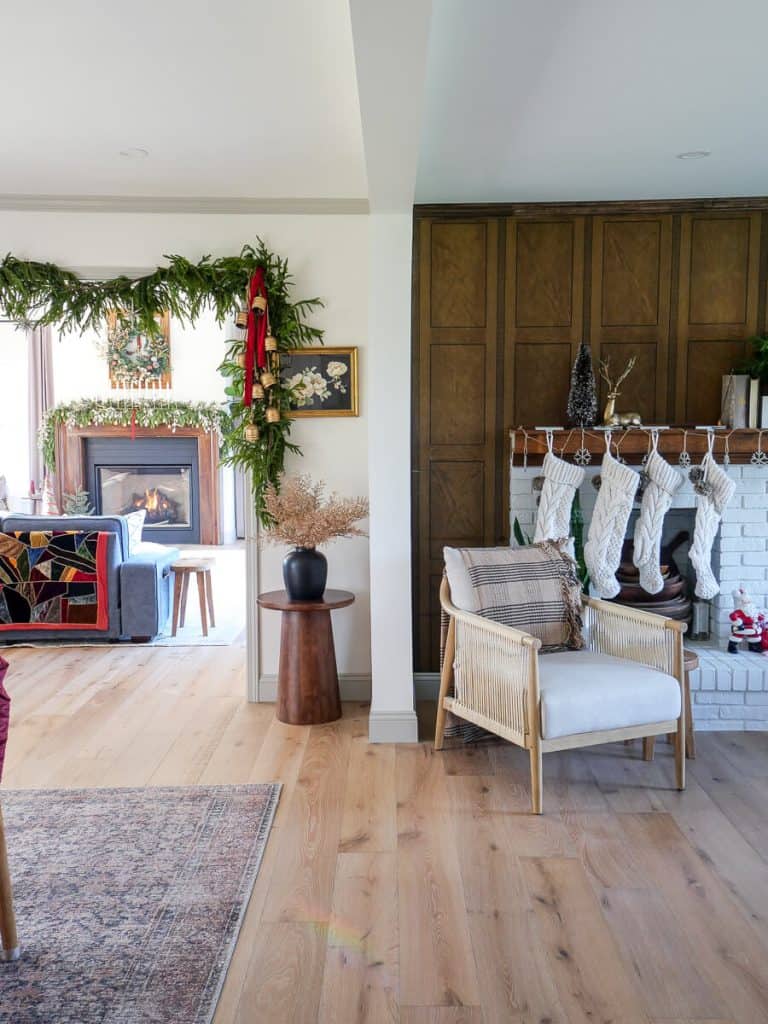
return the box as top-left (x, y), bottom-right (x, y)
top-left (0, 530), bottom-right (110, 631)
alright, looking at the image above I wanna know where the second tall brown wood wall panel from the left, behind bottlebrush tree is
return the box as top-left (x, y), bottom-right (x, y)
top-left (504, 217), bottom-right (584, 427)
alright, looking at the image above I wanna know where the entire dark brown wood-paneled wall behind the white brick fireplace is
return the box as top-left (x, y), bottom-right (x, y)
top-left (413, 199), bottom-right (768, 672)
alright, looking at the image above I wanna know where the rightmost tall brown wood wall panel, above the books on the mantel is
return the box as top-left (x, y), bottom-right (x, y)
top-left (676, 211), bottom-right (760, 424)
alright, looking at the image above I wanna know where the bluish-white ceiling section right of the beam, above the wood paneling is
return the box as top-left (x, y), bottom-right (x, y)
top-left (416, 0), bottom-right (768, 203)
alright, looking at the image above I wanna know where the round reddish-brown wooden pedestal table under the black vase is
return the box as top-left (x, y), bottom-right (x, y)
top-left (258, 590), bottom-right (354, 725)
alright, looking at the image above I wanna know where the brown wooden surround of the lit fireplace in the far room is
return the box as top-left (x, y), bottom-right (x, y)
top-left (55, 423), bottom-right (219, 544)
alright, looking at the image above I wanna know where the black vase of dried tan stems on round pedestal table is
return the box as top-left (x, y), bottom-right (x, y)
top-left (264, 476), bottom-right (369, 601)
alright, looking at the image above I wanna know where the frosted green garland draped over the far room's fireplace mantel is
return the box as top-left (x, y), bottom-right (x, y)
top-left (38, 398), bottom-right (227, 471)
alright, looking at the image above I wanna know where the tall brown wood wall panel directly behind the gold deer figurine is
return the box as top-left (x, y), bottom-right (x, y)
top-left (590, 214), bottom-right (672, 423)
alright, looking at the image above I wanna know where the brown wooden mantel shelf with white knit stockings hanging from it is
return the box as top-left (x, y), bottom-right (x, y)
top-left (509, 426), bottom-right (768, 466)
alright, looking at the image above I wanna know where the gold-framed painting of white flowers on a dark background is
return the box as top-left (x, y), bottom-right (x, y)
top-left (283, 348), bottom-right (358, 416)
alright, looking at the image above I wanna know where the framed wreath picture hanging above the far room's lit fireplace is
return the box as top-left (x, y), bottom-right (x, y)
top-left (106, 313), bottom-right (171, 389)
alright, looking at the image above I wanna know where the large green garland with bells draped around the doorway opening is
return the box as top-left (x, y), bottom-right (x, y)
top-left (0, 239), bottom-right (323, 521)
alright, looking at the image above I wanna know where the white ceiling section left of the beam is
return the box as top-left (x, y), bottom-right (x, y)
top-left (0, 0), bottom-right (367, 199)
